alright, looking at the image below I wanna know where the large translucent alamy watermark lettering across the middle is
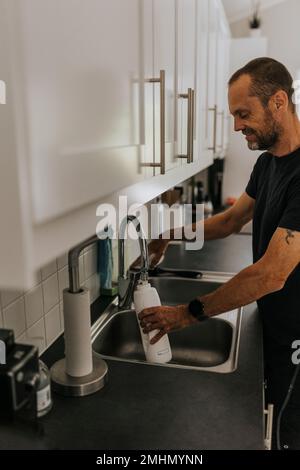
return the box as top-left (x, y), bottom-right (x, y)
top-left (96, 196), bottom-right (204, 250)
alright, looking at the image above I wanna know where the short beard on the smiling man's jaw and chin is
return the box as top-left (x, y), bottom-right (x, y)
top-left (243, 110), bottom-right (282, 150)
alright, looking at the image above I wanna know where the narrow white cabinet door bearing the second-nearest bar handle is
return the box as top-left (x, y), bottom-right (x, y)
top-left (177, 0), bottom-right (197, 164)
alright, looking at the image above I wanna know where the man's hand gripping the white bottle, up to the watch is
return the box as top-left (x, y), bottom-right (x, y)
top-left (138, 305), bottom-right (198, 344)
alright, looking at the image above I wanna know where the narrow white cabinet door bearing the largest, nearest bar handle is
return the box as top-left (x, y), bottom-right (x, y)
top-left (153, 0), bottom-right (178, 174)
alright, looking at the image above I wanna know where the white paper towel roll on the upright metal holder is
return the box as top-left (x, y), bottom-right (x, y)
top-left (63, 288), bottom-right (93, 377)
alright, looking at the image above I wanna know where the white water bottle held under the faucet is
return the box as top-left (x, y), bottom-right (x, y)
top-left (133, 280), bottom-right (172, 364)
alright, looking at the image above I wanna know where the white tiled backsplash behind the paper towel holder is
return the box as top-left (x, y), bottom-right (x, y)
top-left (0, 245), bottom-right (100, 354)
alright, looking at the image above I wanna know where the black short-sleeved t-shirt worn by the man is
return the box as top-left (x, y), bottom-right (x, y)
top-left (246, 149), bottom-right (300, 346)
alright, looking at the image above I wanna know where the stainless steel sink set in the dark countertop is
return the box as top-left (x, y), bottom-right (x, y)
top-left (92, 273), bottom-right (241, 373)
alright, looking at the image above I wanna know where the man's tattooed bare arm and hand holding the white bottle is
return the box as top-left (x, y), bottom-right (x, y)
top-left (139, 228), bottom-right (300, 344)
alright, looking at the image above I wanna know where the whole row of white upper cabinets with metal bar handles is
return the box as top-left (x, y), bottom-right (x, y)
top-left (0, 0), bottom-right (231, 288)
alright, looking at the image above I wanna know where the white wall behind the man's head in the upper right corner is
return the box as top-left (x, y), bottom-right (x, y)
top-left (230, 0), bottom-right (300, 78)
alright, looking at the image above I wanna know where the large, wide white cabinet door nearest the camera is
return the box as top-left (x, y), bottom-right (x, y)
top-left (9, 0), bottom-right (144, 222)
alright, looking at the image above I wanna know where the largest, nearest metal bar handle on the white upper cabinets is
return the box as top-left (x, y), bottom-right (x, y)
top-left (141, 70), bottom-right (166, 175)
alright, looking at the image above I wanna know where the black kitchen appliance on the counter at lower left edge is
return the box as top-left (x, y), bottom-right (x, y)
top-left (0, 329), bottom-right (39, 420)
